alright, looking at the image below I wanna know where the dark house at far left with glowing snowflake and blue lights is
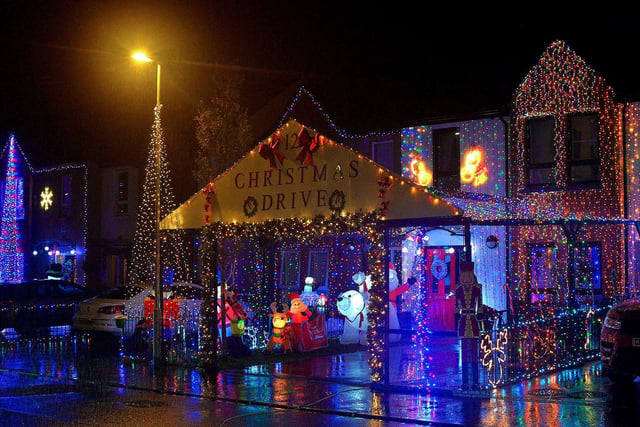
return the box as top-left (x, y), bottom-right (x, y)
top-left (0, 135), bottom-right (138, 291)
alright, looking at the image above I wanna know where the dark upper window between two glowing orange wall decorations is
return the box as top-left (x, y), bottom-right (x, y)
top-left (433, 128), bottom-right (460, 191)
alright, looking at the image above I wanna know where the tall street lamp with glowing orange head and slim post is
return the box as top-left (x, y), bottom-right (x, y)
top-left (131, 52), bottom-right (164, 363)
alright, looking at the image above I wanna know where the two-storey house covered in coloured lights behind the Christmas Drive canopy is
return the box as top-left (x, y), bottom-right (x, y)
top-left (357, 41), bottom-right (639, 330)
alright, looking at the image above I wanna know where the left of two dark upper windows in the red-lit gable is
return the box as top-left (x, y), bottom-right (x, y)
top-left (526, 117), bottom-right (556, 187)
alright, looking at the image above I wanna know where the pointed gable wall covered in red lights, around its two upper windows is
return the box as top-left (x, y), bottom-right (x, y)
top-left (509, 41), bottom-right (622, 218)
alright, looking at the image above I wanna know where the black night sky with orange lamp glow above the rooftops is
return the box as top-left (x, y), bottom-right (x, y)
top-left (0, 0), bottom-right (640, 201)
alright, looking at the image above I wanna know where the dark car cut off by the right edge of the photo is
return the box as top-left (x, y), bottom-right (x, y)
top-left (600, 299), bottom-right (640, 382)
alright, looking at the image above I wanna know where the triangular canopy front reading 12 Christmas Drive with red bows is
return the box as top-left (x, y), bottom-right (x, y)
top-left (160, 120), bottom-right (462, 230)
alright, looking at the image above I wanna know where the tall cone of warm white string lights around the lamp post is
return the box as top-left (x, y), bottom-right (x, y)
top-left (127, 105), bottom-right (189, 284)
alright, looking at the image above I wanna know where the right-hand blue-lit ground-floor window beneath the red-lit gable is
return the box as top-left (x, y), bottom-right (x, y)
top-left (573, 242), bottom-right (602, 305)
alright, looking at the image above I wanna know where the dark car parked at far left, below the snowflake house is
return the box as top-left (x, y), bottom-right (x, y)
top-left (0, 279), bottom-right (91, 336)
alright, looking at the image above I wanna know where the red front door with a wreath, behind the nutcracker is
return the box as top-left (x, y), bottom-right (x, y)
top-left (424, 247), bottom-right (458, 332)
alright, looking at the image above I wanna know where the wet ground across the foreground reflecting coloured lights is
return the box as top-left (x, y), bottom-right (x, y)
top-left (0, 332), bottom-right (640, 427)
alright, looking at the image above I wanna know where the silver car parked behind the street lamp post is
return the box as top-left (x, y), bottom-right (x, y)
top-left (73, 282), bottom-right (204, 336)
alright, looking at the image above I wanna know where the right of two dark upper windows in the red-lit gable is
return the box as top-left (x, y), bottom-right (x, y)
top-left (567, 114), bottom-right (600, 184)
